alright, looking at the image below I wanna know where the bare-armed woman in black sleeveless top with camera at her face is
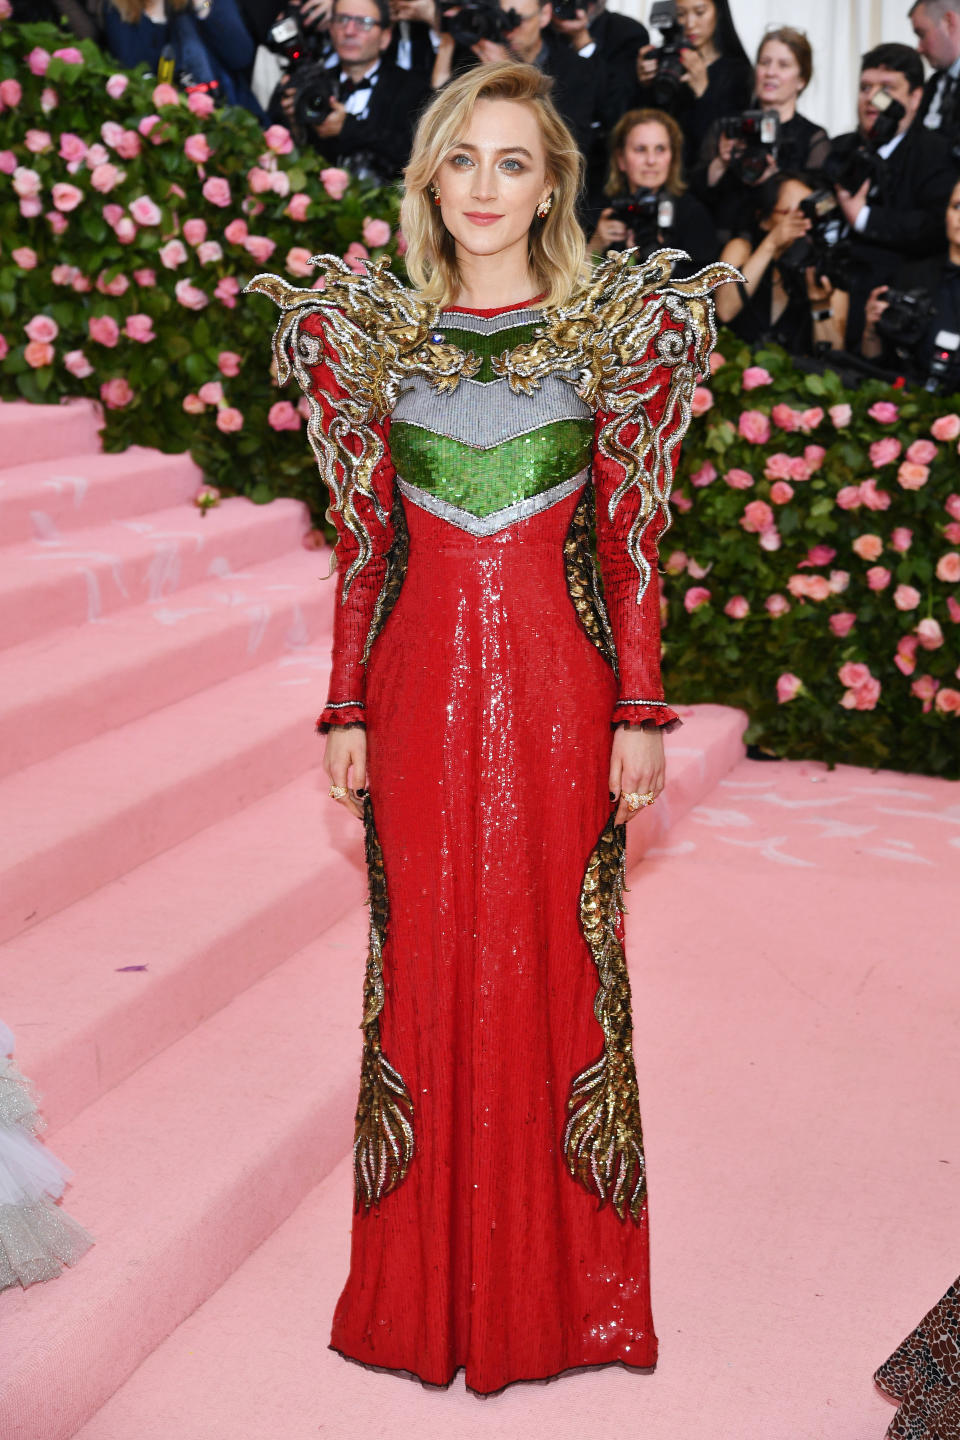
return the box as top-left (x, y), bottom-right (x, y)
top-left (717, 173), bottom-right (846, 356)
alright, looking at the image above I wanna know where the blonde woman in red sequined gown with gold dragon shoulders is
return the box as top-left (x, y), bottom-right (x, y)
top-left (248, 63), bottom-right (721, 1394)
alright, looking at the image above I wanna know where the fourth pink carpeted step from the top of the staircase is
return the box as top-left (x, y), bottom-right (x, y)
top-left (0, 549), bottom-right (334, 776)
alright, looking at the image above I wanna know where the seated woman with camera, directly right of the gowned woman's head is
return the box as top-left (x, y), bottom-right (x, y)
top-left (587, 109), bottom-right (720, 274)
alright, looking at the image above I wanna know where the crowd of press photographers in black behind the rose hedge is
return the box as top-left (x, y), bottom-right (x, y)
top-left (14, 0), bottom-right (960, 392)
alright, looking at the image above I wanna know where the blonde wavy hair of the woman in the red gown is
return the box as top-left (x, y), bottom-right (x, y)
top-left (400, 60), bottom-right (590, 305)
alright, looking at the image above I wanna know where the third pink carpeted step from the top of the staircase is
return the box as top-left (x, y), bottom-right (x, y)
top-left (0, 497), bottom-right (309, 645)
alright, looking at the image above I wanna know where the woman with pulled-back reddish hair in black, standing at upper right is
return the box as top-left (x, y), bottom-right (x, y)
top-left (692, 24), bottom-right (830, 233)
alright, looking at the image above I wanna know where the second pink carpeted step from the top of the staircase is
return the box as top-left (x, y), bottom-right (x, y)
top-left (0, 443), bottom-right (203, 544)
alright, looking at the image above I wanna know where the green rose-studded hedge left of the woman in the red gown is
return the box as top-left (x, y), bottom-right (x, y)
top-left (0, 12), bottom-right (397, 523)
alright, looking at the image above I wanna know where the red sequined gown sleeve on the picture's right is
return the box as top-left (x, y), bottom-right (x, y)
top-left (593, 311), bottom-right (692, 727)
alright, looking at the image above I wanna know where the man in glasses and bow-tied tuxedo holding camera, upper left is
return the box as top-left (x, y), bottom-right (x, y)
top-left (282, 0), bottom-right (429, 184)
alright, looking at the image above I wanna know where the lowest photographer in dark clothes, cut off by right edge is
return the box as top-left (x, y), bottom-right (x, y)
top-left (861, 181), bottom-right (960, 393)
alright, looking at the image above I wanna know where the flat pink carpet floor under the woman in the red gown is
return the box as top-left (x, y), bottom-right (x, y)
top-left (65, 762), bottom-right (960, 1440)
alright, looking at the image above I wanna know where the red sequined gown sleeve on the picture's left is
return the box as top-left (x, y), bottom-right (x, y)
top-left (301, 314), bottom-right (394, 732)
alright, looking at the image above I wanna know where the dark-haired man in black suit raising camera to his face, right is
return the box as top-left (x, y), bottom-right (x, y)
top-left (823, 45), bottom-right (954, 348)
